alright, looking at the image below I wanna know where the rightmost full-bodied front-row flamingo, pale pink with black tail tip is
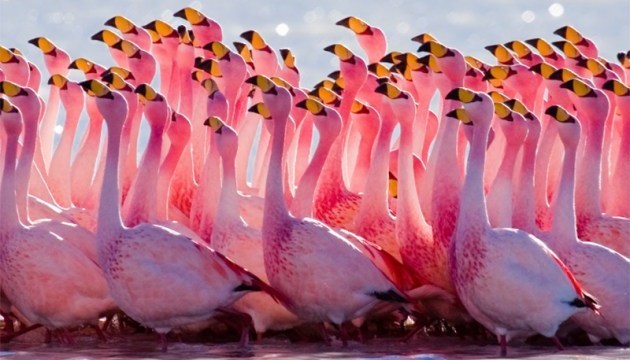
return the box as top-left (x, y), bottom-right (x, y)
top-left (446, 88), bottom-right (599, 356)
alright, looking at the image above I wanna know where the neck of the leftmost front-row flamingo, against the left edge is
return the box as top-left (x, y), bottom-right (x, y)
top-left (0, 135), bottom-right (21, 229)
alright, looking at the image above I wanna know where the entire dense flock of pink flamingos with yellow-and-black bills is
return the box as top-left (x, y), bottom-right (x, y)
top-left (0, 7), bottom-right (630, 356)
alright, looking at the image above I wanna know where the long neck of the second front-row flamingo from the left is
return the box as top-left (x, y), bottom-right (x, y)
top-left (96, 122), bottom-right (123, 236)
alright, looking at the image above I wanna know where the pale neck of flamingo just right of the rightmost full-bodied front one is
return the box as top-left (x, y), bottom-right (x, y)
top-left (549, 136), bottom-right (577, 241)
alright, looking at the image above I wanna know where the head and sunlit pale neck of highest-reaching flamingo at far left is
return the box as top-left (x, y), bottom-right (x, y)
top-left (28, 37), bottom-right (70, 172)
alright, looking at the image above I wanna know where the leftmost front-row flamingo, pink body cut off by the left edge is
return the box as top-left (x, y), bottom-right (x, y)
top-left (0, 99), bottom-right (115, 340)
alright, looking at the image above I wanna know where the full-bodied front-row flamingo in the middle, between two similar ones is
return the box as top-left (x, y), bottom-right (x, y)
top-left (247, 75), bottom-right (405, 342)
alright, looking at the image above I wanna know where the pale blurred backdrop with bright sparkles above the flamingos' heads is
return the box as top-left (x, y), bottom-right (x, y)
top-left (0, 0), bottom-right (630, 90)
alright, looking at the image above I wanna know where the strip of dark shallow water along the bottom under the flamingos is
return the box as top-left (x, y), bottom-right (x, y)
top-left (0, 335), bottom-right (630, 360)
